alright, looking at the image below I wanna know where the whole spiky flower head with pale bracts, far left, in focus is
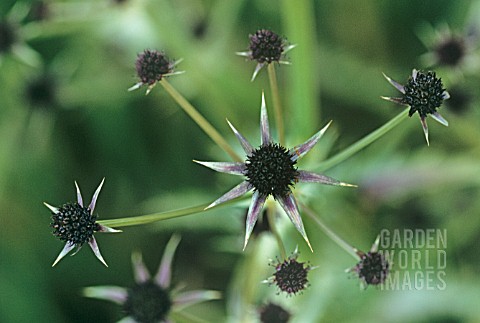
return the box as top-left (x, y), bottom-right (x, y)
top-left (44, 179), bottom-right (120, 267)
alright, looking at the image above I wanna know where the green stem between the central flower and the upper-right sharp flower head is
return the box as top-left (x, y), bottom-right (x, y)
top-left (315, 109), bottom-right (408, 172)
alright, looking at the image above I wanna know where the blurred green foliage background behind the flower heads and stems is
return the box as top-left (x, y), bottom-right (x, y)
top-left (0, 0), bottom-right (480, 322)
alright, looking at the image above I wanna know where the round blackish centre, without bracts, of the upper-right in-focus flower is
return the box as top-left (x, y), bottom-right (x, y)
top-left (402, 71), bottom-right (445, 118)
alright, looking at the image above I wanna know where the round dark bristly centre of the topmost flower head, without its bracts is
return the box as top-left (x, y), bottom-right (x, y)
top-left (250, 29), bottom-right (285, 63)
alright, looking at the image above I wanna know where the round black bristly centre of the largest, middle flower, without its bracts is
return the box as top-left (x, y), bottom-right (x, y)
top-left (245, 143), bottom-right (298, 198)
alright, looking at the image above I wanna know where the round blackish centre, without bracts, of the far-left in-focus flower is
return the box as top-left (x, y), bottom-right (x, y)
top-left (50, 202), bottom-right (99, 247)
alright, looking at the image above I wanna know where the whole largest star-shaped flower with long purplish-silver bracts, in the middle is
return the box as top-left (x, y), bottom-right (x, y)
top-left (195, 95), bottom-right (354, 249)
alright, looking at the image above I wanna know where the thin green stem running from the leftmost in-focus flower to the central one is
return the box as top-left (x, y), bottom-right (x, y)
top-left (97, 196), bottom-right (247, 228)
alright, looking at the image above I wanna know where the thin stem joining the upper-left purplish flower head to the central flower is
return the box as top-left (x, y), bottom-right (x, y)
top-left (159, 78), bottom-right (242, 161)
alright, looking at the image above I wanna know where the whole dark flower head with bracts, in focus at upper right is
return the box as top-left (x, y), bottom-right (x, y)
top-left (382, 69), bottom-right (450, 144)
